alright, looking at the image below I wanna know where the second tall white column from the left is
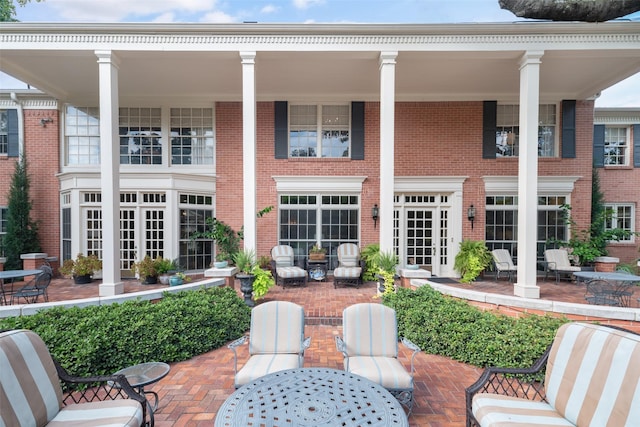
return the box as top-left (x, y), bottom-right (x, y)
top-left (240, 52), bottom-right (257, 250)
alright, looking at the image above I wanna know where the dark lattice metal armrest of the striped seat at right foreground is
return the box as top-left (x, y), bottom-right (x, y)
top-left (465, 345), bottom-right (551, 426)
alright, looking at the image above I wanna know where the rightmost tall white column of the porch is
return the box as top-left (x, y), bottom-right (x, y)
top-left (513, 51), bottom-right (544, 298)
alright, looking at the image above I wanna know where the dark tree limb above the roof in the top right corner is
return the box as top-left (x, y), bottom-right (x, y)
top-left (498, 0), bottom-right (640, 22)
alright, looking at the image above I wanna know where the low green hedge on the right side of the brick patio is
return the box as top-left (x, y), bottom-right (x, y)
top-left (383, 285), bottom-right (567, 368)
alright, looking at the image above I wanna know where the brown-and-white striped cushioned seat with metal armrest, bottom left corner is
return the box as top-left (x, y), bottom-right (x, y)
top-left (0, 329), bottom-right (153, 427)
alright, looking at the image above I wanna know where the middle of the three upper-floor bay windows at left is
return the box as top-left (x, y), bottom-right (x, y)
top-left (119, 108), bottom-right (162, 165)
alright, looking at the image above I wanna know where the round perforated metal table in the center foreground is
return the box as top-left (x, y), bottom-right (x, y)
top-left (215, 368), bottom-right (409, 427)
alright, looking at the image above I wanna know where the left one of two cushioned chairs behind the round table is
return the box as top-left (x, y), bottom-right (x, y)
top-left (228, 301), bottom-right (311, 388)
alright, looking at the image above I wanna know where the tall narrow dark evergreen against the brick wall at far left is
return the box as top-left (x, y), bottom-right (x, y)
top-left (3, 156), bottom-right (40, 270)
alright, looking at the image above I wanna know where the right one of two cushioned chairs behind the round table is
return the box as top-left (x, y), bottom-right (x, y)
top-left (336, 303), bottom-right (420, 413)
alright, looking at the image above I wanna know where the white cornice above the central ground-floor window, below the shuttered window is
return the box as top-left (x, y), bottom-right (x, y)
top-left (272, 176), bottom-right (367, 193)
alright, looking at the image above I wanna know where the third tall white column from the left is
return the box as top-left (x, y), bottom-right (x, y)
top-left (378, 52), bottom-right (398, 252)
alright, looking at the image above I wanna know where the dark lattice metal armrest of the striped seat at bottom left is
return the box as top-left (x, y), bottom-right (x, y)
top-left (53, 359), bottom-right (155, 427)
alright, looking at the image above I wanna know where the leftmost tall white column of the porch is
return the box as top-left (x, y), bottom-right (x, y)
top-left (96, 51), bottom-right (124, 296)
